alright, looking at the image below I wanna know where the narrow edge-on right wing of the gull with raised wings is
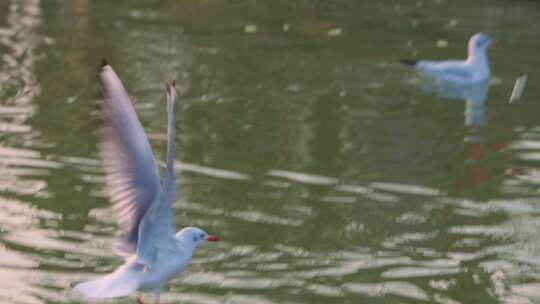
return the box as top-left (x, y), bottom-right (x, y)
top-left (137, 82), bottom-right (176, 268)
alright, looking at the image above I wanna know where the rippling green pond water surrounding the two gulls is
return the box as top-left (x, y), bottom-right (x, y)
top-left (0, 0), bottom-right (540, 304)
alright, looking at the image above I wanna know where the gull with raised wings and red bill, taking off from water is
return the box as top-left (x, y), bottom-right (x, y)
top-left (74, 60), bottom-right (218, 304)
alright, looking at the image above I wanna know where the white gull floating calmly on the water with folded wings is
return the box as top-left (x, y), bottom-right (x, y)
top-left (400, 33), bottom-right (495, 85)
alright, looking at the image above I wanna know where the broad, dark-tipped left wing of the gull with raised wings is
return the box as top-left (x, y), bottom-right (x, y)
top-left (99, 62), bottom-right (160, 255)
